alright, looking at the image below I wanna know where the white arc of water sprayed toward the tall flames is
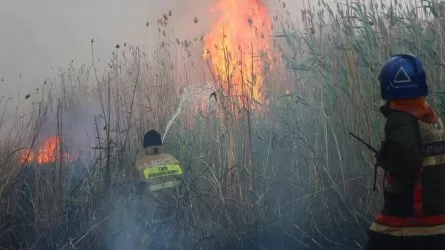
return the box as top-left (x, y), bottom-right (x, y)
top-left (162, 83), bottom-right (214, 143)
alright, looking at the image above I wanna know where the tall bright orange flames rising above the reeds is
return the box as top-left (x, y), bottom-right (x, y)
top-left (204, 0), bottom-right (272, 106)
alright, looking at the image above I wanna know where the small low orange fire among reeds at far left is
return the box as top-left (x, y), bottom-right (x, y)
top-left (19, 136), bottom-right (74, 165)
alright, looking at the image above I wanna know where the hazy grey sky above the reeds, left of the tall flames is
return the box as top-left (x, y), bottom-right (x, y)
top-left (0, 0), bottom-right (312, 96)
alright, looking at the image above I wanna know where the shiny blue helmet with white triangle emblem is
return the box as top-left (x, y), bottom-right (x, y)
top-left (379, 54), bottom-right (428, 100)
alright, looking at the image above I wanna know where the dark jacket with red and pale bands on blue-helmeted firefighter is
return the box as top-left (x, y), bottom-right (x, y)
top-left (370, 105), bottom-right (445, 236)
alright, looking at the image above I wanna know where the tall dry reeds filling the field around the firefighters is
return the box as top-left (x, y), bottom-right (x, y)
top-left (0, 0), bottom-right (445, 249)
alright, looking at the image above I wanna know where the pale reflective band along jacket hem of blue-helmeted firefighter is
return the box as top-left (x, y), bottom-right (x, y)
top-left (370, 222), bottom-right (445, 236)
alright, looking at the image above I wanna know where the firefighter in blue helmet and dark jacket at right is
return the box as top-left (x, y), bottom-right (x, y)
top-left (365, 54), bottom-right (445, 250)
